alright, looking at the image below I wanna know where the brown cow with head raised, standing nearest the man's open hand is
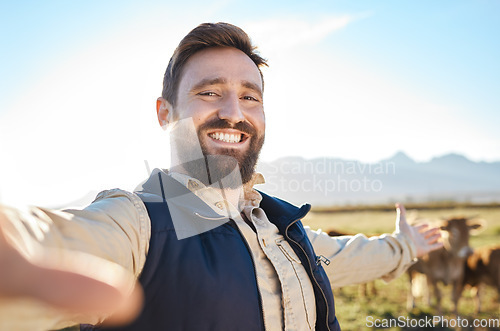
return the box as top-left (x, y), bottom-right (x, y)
top-left (408, 217), bottom-right (484, 314)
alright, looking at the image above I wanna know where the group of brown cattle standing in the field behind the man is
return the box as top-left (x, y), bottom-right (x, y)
top-left (328, 217), bottom-right (500, 314)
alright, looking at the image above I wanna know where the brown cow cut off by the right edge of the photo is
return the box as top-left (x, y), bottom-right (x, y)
top-left (463, 245), bottom-right (500, 313)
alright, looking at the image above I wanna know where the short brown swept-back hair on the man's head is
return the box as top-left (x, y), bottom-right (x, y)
top-left (161, 22), bottom-right (267, 107)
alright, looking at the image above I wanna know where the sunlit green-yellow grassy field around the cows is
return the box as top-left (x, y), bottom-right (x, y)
top-left (304, 206), bottom-right (500, 331)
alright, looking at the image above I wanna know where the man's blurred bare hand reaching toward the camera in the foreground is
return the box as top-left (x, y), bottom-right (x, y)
top-left (0, 209), bottom-right (142, 323)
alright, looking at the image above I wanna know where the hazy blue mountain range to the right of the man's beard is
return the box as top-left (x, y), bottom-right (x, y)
top-left (258, 152), bottom-right (500, 205)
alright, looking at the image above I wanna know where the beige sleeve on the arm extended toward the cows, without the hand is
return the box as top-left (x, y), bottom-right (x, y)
top-left (307, 228), bottom-right (416, 288)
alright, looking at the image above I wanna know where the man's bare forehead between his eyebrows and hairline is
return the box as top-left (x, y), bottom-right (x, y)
top-left (179, 47), bottom-right (262, 93)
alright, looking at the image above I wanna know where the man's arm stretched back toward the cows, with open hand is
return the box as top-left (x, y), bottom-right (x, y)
top-left (307, 205), bottom-right (442, 288)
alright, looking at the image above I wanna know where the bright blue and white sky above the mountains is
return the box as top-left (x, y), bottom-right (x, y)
top-left (0, 0), bottom-right (500, 206)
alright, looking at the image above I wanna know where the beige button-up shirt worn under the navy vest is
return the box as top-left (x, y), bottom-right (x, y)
top-left (0, 174), bottom-right (415, 330)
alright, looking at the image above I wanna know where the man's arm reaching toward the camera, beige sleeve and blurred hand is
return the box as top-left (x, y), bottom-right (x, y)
top-left (0, 190), bottom-right (149, 330)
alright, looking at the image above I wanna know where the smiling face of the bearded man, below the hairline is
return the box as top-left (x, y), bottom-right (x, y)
top-left (163, 47), bottom-right (265, 187)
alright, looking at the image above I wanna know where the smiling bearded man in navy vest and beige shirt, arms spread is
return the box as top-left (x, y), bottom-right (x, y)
top-left (0, 23), bottom-right (440, 330)
